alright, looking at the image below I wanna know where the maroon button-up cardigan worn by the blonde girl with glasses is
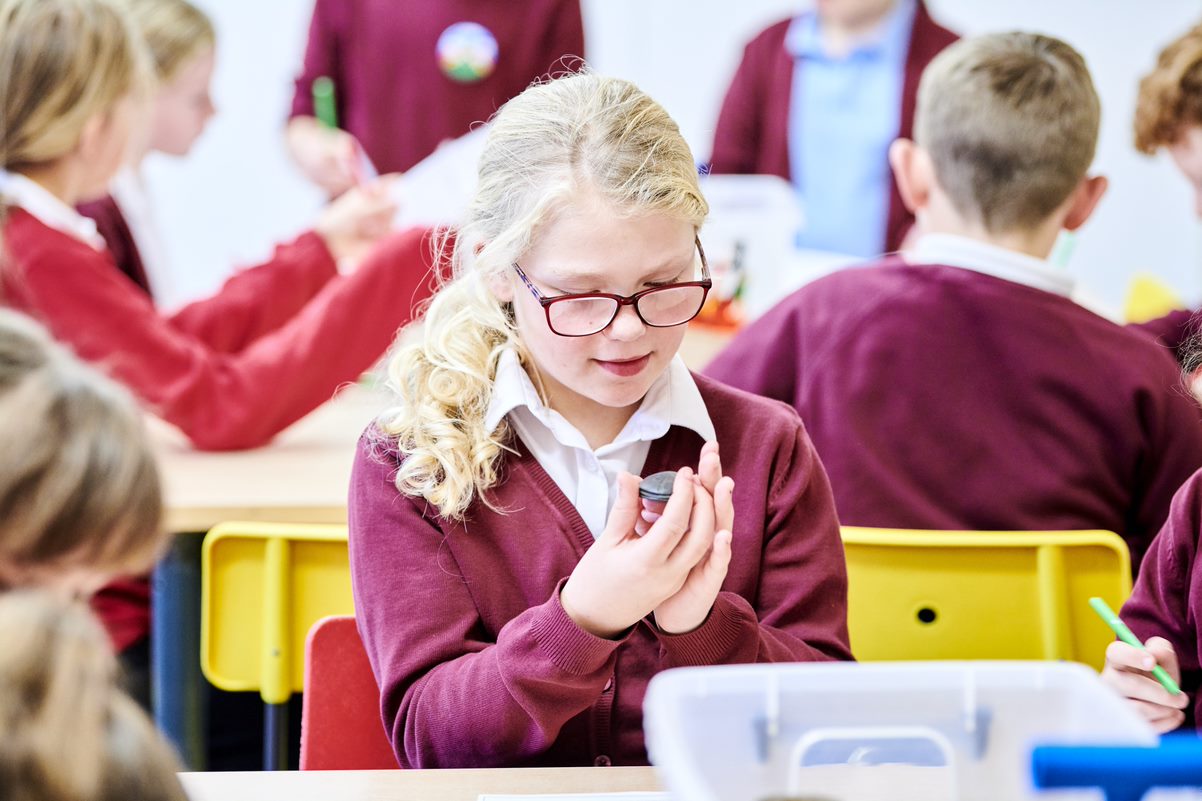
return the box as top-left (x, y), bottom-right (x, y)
top-left (350, 376), bottom-right (850, 767)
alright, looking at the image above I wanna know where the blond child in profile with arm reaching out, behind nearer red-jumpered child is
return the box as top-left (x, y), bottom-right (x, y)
top-left (79, 0), bottom-right (395, 312)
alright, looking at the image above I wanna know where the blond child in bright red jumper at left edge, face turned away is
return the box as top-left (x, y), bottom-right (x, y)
top-left (0, 0), bottom-right (428, 449)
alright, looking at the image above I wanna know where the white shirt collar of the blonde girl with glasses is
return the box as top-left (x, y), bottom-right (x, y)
top-left (484, 349), bottom-right (718, 455)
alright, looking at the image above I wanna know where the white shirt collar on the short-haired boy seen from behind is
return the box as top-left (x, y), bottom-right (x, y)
top-left (904, 233), bottom-right (1073, 297)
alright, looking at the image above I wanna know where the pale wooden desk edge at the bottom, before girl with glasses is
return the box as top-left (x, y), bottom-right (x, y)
top-left (179, 767), bottom-right (662, 801)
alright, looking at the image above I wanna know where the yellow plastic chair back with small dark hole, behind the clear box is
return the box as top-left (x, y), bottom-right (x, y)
top-left (843, 526), bottom-right (1131, 669)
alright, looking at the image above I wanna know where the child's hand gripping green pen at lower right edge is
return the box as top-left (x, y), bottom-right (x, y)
top-left (1102, 637), bottom-right (1190, 734)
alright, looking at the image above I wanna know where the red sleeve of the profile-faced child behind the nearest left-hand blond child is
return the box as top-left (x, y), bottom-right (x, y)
top-left (171, 231), bottom-right (338, 354)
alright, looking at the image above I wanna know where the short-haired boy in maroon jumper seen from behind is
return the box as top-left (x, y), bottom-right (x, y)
top-left (707, 32), bottom-right (1202, 564)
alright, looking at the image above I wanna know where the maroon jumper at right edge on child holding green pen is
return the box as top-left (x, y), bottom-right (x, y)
top-left (1121, 471), bottom-right (1202, 728)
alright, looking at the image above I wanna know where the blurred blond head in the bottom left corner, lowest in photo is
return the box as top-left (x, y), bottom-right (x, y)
top-left (0, 591), bottom-right (186, 801)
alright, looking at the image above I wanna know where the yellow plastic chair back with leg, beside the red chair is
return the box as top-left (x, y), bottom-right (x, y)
top-left (201, 523), bottom-right (355, 770)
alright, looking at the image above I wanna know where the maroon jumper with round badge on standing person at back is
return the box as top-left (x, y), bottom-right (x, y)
top-left (291, 0), bottom-right (584, 172)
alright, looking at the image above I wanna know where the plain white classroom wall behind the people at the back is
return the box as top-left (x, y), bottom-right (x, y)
top-left (147, 0), bottom-right (1202, 307)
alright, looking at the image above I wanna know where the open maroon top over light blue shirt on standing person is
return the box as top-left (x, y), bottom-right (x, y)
top-left (710, 0), bottom-right (958, 250)
